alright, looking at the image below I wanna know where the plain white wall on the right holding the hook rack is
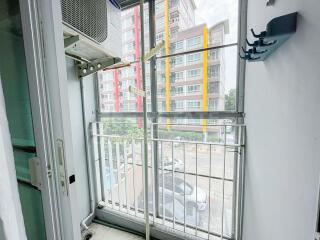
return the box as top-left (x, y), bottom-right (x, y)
top-left (243, 0), bottom-right (320, 240)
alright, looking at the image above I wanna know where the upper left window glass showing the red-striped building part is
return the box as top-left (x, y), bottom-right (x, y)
top-left (98, 4), bottom-right (150, 112)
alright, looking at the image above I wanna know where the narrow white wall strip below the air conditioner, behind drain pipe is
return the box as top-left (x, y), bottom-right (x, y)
top-left (66, 58), bottom-right (96, 223)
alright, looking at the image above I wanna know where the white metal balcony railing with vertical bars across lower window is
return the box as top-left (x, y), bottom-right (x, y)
top-left (91, 122), bottom-right (244, 239)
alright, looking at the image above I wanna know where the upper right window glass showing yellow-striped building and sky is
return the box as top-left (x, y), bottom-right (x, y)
top-left (156, 0), bottom-right (238, 112)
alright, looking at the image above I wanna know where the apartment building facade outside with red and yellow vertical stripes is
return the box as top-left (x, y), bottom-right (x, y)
top-left (99, 0), bottom-right (228, 129)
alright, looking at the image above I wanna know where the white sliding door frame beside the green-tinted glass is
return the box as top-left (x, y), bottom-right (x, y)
top-left (20, 0), bottom-right (61, 239)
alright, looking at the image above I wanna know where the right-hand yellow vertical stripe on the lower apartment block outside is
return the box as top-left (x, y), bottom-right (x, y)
top-left (202, 26), bottom-right (208, 132)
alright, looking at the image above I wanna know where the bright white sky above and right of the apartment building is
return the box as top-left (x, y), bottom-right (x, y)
top-left (194, 0), bottom-right (238, 92)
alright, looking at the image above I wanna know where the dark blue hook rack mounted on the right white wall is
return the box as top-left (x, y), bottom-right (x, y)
top-left (239, 12), bottom-right (298, 62)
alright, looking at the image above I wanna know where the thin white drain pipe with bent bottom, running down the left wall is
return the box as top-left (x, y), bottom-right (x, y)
top-left (80, 78), bottom-right (95, 232)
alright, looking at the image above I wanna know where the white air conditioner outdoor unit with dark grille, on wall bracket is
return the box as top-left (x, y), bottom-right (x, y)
top-left (61, 0), bottom-right (122, 62)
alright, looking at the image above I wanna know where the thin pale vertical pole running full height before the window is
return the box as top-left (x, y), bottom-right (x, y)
top-left (140, 0), bottom-right (150, 240)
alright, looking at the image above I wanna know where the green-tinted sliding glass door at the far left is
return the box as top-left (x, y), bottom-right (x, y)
top-left (0, 0), bottom-right (46, 240)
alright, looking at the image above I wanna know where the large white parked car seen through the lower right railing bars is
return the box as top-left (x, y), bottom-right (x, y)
top-left (159, 174), bottom-right (208, 211)
